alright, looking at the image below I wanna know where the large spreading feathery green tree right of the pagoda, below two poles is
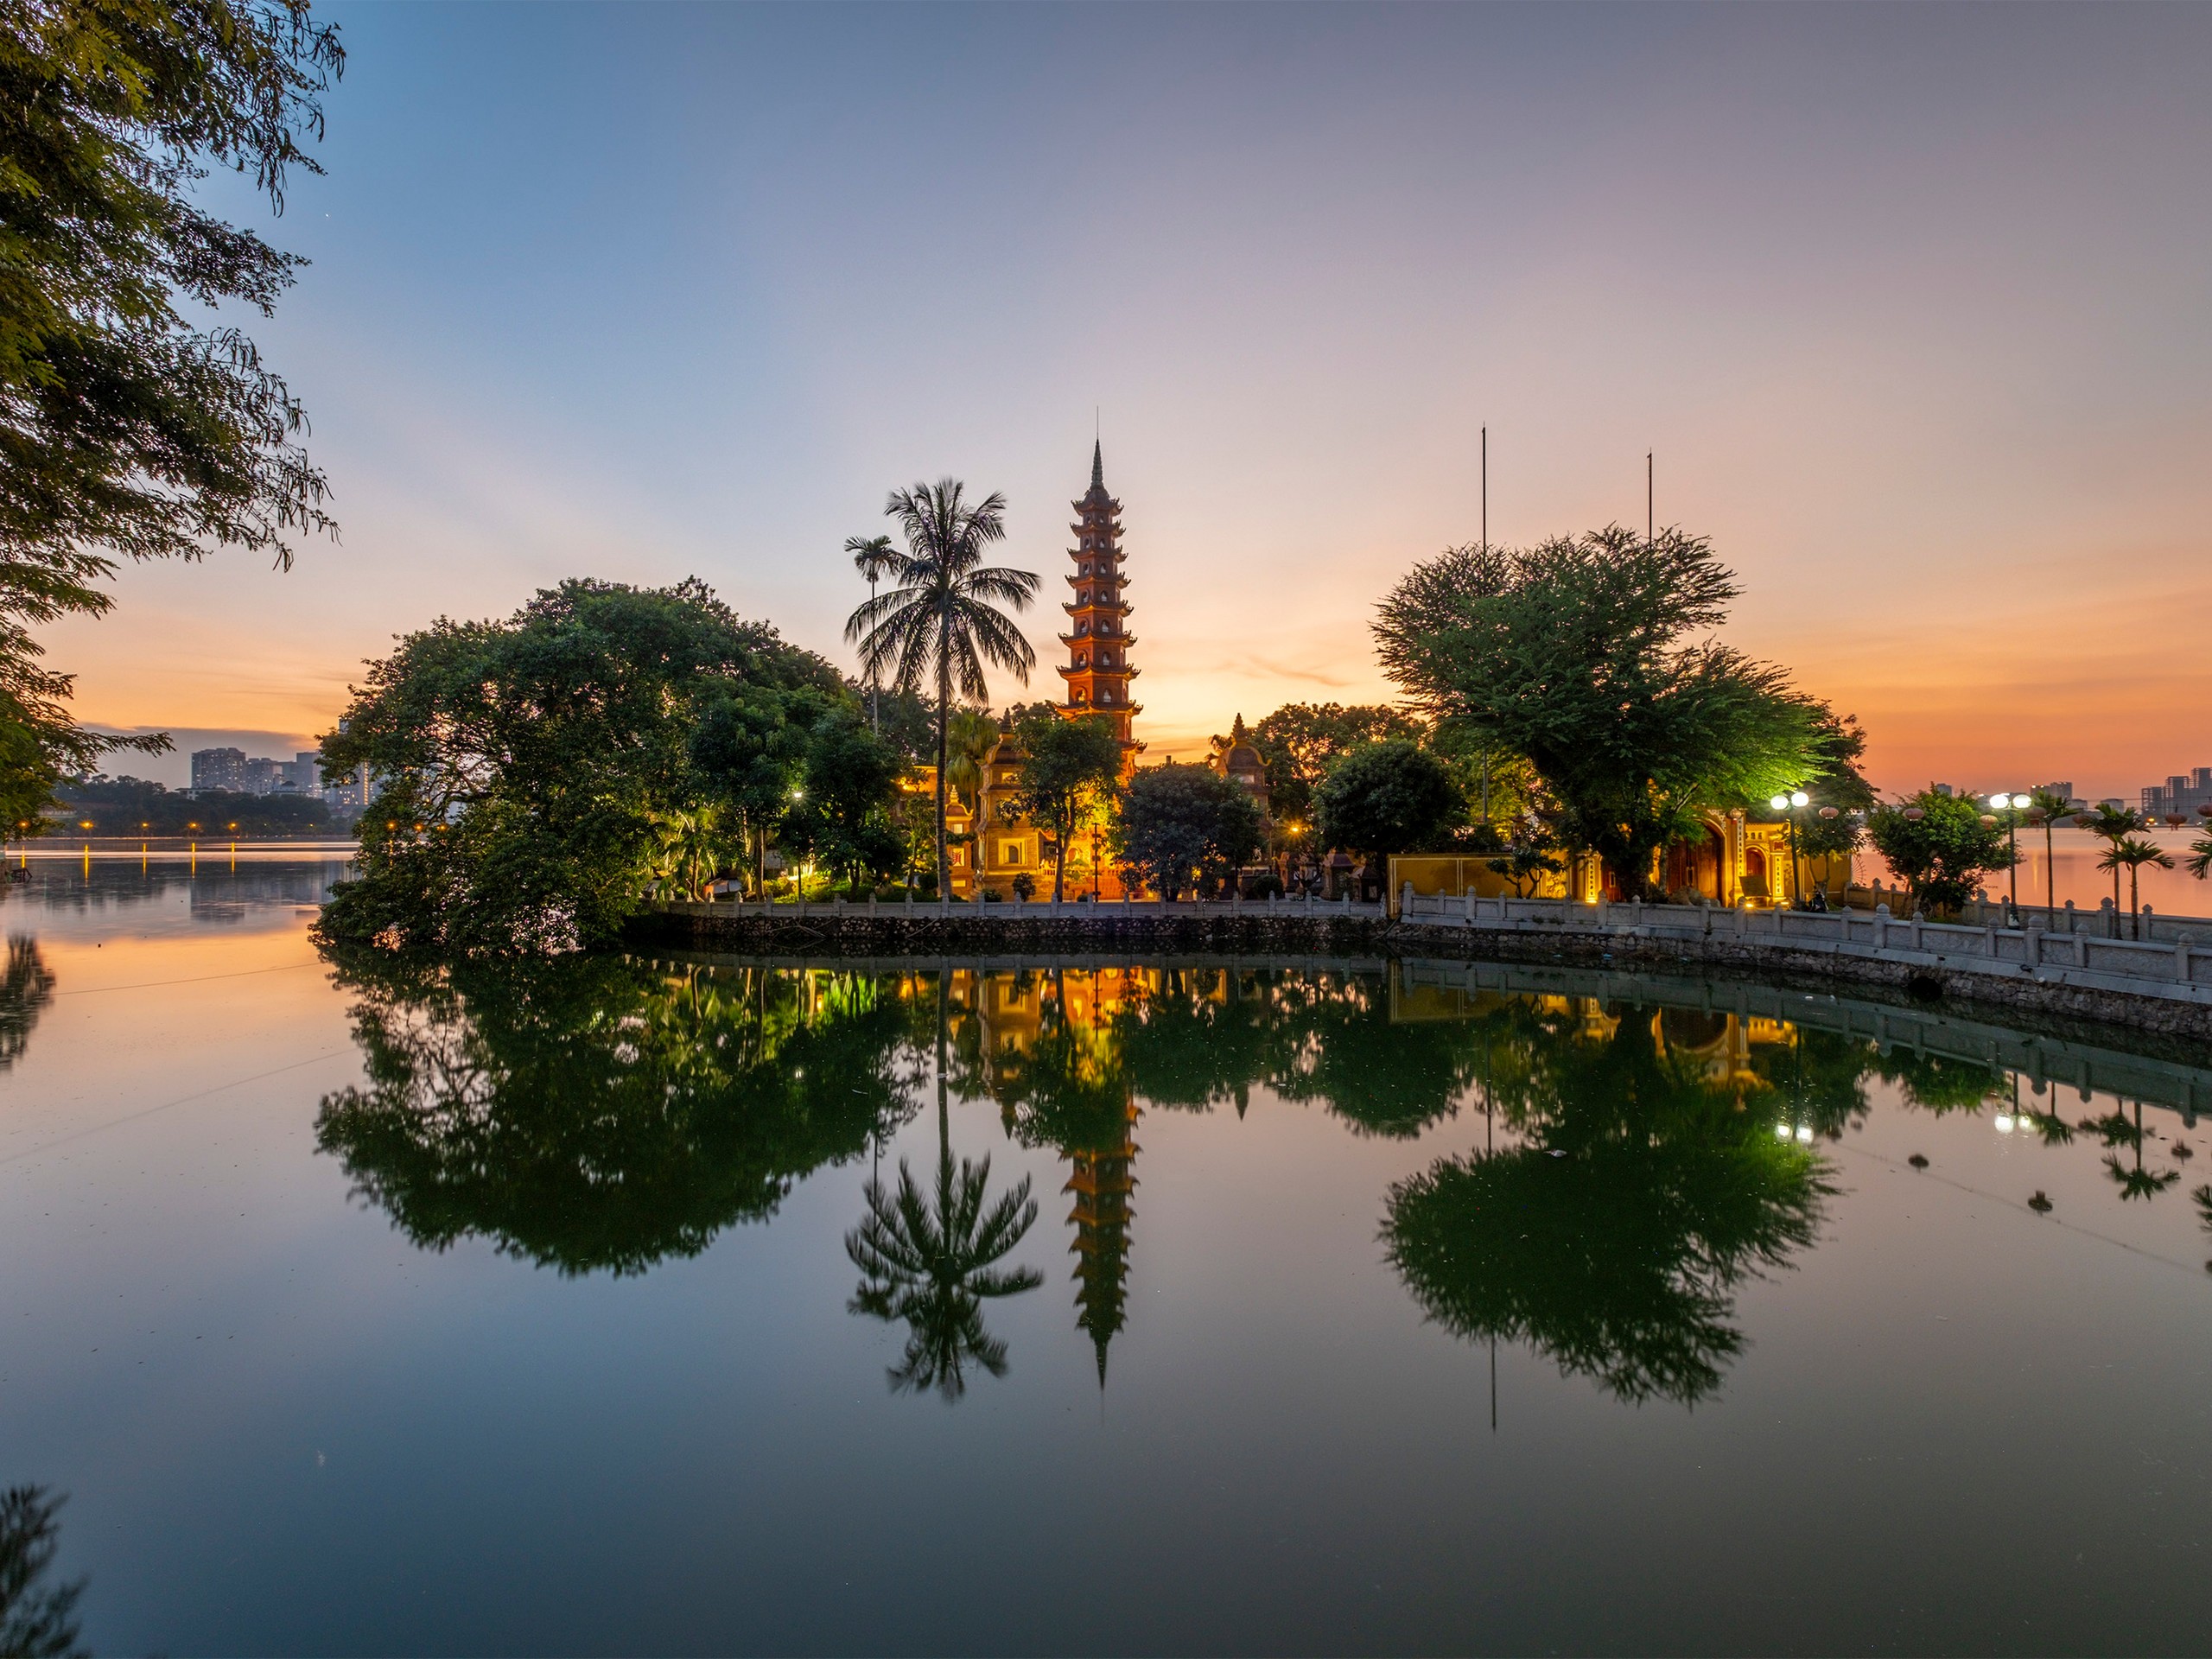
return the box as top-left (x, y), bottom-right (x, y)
top-left (1376, 524), bottom-right (1829, 896)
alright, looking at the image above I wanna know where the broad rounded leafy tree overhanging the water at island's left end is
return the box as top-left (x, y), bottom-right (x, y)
top-left (321, 580), bottom-right (845, 953)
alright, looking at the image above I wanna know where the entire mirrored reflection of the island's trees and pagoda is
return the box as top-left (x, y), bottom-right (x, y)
top-left (319, 957), bottom-right (2212, 1405)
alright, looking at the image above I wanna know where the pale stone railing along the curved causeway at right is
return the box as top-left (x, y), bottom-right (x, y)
top-left (1400, 887), bottom-right (2212, 1007)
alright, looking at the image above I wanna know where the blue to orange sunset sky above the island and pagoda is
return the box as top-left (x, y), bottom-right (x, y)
top-left (44, 4), bottom-right (2212, 797)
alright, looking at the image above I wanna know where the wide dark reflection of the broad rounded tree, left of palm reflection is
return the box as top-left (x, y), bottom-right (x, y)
top-left (316, 953), bottom-right (916, 1274)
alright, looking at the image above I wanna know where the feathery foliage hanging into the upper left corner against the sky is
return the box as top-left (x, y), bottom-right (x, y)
top-left (0, 0), bottom-right (345, 825)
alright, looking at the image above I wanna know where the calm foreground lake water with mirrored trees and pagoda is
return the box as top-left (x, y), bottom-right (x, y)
top-left (0, 856), bottom-right (2212, 1655)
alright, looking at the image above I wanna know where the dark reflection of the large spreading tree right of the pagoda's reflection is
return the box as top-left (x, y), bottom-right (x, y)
top-left (1382, 1002), bottom-right (1831, 1405)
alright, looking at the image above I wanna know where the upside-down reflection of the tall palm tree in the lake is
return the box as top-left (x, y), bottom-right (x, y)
top-left (845, 973), bottom-right (1044, 1405)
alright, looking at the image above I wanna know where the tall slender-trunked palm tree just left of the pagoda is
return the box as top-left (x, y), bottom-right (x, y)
top-left (845, 478), bottom-right (1038, 893)
